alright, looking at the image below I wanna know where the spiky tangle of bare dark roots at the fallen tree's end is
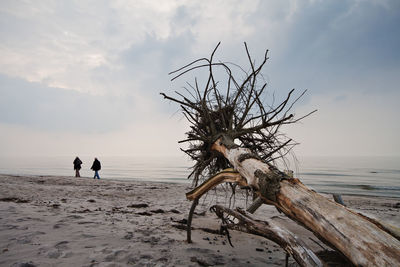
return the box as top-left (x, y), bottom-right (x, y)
top-left (161, 43), bottom-right (315, 185)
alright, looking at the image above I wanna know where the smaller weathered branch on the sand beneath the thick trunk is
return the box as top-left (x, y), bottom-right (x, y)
top-left (211, 205), bottom-right (322, 266)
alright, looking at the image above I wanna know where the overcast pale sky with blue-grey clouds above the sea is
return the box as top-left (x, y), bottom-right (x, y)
top-left (0, 0), bottom-right (400, 157)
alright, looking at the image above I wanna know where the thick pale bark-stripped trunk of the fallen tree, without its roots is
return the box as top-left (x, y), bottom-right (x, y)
top-left (213, 140), bottom-right (400, 266)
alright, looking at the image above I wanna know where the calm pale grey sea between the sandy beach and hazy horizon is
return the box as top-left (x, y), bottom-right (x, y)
top-left (0, 156), bottom-right (400, 198)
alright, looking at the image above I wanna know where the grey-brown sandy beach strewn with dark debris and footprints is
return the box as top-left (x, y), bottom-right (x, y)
top-left (0, 175), bottom-right (400, 267)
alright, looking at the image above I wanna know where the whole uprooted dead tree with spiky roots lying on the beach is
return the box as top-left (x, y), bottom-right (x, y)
top-left (162, 44), bottom-right (400, 266)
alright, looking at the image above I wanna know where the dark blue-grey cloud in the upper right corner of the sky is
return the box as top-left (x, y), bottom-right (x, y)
top-left (260, 1), bottom-right (400, 93)
